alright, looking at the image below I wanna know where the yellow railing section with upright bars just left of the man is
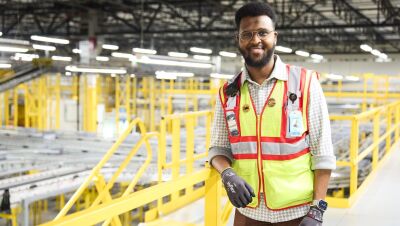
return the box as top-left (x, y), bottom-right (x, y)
top-left (145, 111), bottom-right (212, 221)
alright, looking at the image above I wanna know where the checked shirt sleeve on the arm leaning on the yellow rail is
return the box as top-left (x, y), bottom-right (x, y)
top-left (208, 95), bottom-right (233, 163)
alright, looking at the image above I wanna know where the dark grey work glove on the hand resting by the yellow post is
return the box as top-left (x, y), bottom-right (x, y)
top-left (221, 168), bottom-right (256, 208)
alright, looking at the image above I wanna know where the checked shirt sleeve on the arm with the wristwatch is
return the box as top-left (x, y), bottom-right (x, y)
top-left (308, 76), bottom-right (336, 170)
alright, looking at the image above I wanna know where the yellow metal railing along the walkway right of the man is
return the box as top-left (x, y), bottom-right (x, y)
top-left (327, 101), bottom-right (400, 208)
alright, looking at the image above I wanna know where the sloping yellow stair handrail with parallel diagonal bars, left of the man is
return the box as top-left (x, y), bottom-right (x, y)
top-left (55, 118), bottom-right (157, 220)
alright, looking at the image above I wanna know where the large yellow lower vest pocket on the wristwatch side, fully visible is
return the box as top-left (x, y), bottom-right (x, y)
top-left (263, 153), bottom-right (314, 209)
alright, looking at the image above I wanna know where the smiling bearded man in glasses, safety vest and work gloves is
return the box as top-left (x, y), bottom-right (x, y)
top-left (209, 2), bottom-right (336, 226)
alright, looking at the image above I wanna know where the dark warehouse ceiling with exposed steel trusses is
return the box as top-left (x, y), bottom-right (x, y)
top-left (0, 0), bottom-right (400, 54)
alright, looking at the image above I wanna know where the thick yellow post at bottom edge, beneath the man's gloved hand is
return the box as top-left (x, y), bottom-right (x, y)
top-left (204, 166), bottom-right (222, 226)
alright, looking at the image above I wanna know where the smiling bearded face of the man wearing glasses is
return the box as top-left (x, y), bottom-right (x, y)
top-left (238, 15), bottom-right (278, 68)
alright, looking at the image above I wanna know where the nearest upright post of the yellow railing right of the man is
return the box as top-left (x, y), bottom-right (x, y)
top-left (350, 117), bottom-right (359, 196)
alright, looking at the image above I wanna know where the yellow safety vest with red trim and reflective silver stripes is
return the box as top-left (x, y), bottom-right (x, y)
top-left (219, 65), bottom-right (318, 210)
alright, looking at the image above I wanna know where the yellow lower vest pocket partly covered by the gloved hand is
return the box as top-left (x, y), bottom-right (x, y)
top-left (232, 159), bottom-right (258, 207)
